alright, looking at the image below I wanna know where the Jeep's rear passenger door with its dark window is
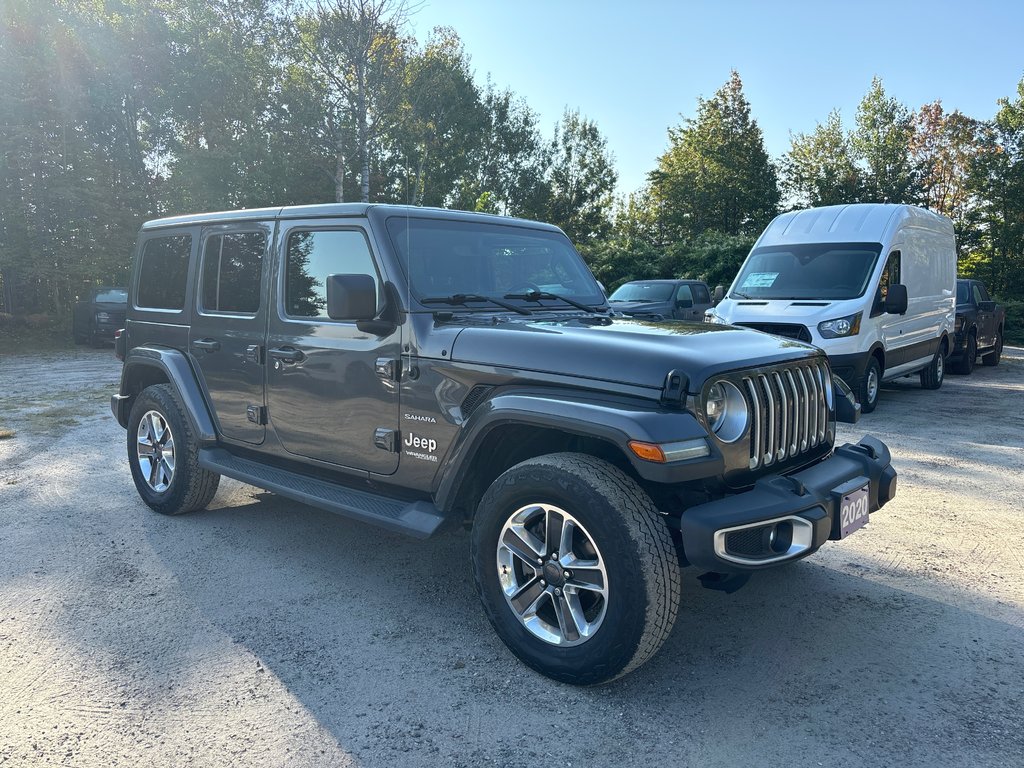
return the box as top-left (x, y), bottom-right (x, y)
top-left (188, 222), bottom-right (273, 444)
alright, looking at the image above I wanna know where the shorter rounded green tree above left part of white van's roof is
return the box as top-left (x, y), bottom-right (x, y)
top-left (782, 110), bottom-right (861, 207)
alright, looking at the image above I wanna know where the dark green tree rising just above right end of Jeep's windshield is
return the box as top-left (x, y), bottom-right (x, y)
top-left (546, 110), bottom-right (618, 243)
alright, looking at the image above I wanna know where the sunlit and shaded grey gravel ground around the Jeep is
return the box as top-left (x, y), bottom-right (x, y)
top-left (0, 349), bottom-right (1024, 768)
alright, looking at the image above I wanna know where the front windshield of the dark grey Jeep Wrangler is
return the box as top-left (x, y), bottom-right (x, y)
top-left (387, 216), bottom-right (604, 309)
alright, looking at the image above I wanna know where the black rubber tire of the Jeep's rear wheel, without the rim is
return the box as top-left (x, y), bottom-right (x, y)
top-left (128, 384), bottom-right (220, 515)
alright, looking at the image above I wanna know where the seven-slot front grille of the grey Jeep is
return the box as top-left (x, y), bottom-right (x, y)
top-left (742, 360), bottom-right (831, 469)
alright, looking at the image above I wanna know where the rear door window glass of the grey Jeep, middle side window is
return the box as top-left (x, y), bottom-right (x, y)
top-left (200, 232), bottom-right (266, 314)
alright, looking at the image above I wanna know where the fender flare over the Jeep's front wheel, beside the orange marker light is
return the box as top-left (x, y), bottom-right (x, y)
top-left (433, 389), bottom-right (724, 509)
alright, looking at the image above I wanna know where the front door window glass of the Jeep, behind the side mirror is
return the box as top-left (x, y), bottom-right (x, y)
top-left (285, 229), bottom-right (380, 318)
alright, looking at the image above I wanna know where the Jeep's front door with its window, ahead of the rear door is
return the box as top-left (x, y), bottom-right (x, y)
top-left (267, 219), bottom-right (401, 474)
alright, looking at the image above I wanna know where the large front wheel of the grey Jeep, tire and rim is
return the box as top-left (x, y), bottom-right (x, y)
top-left (472, 454), bottom-right (680, 685)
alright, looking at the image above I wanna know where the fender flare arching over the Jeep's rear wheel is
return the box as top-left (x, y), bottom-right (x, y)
top-left (111, 346), bottom-right (217, 445)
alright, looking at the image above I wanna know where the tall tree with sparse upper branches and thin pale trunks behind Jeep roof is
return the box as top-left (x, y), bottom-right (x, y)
top-left (297, 0), bottom-right (410, 203)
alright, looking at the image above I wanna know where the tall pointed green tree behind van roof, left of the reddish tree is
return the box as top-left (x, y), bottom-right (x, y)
top-left (851, 77), bottom-right (918, 203)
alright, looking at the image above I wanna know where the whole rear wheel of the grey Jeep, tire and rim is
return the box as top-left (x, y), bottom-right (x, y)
top-left (128, 384), bottom-right (220, 515)
